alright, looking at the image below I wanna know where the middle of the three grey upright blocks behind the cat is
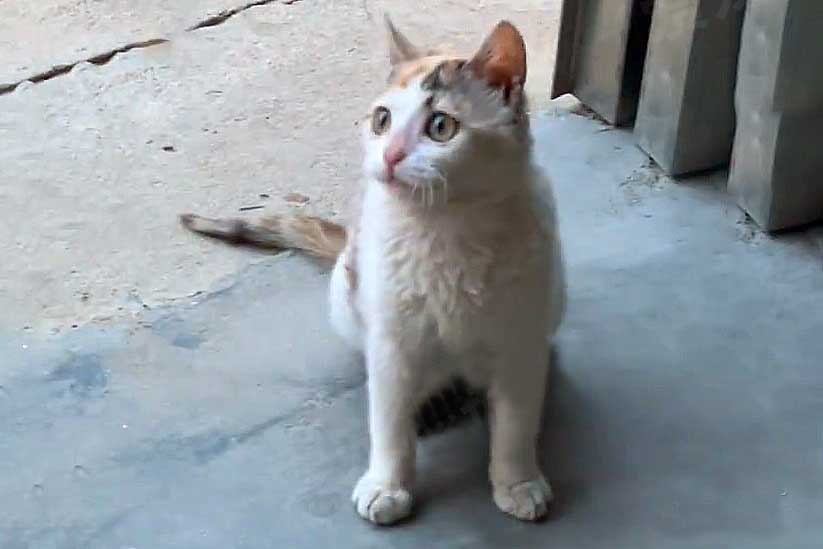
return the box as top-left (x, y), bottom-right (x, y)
top-left (635, 0), bottom-right (746, 175)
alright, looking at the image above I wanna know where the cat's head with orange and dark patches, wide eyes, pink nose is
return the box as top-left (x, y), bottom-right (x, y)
top-left (364, 18), bottom-right (531, 203)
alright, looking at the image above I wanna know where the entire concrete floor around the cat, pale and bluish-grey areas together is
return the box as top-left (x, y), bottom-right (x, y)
top-left (0, 0), bottom-right (823, 549)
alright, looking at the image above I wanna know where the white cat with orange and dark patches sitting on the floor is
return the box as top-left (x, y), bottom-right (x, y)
top-left (181, 18), bottom-right (565, 524)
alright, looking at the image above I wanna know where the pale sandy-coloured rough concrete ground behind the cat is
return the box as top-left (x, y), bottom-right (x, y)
top-left (0, 0), bottom-right (561, 333)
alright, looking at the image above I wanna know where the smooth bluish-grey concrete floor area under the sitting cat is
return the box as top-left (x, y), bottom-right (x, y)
top-left (0, 115), bottom-right (823, 549)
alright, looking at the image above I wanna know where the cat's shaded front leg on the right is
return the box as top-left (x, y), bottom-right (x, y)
top-left (488, 341), bottom-right (553, 520)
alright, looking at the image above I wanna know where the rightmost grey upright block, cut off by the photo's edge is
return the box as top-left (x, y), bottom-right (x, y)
top-left (729, 0), bottom-right (823, 230)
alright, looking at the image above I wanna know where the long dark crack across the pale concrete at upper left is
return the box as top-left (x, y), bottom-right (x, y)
top-left (0, 0), bottom-right (301, 95)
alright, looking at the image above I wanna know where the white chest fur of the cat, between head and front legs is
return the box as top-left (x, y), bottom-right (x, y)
top-left (358, 180), bottom-right (553, 351)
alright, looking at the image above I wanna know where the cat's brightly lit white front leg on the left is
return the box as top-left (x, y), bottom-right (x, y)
top-left (352, 333), bottom-right (419, 525)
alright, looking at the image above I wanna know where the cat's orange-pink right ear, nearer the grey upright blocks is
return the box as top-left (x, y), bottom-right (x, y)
top-left (467, 21), bottom-right (526, 96)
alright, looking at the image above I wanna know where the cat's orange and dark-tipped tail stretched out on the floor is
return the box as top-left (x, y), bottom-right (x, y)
top-left (180, 214), bottom-right (346, 260)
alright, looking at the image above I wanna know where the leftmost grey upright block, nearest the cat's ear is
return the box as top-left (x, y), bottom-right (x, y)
top-left (552, 0), bottom-right (653, 126)
